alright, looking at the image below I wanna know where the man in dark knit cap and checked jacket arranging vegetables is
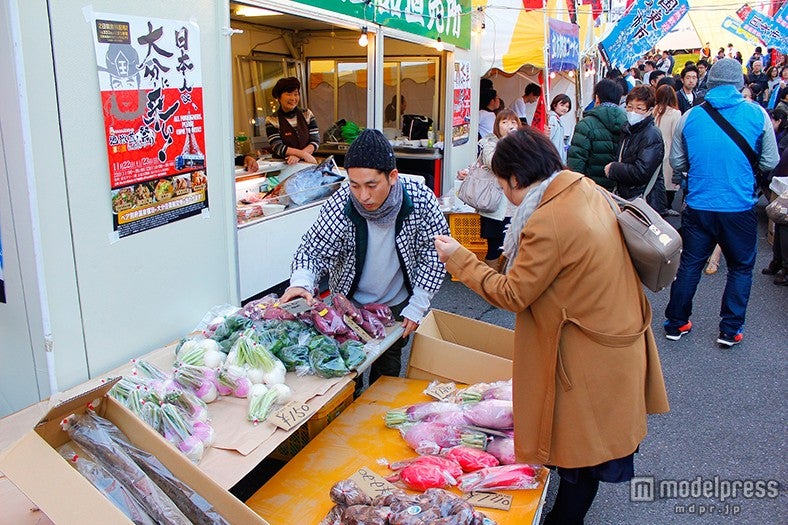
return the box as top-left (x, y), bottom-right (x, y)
top-left (282, 129), bottom-right (449, 390)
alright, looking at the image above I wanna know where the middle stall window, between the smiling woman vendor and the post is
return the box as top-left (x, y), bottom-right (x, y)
top-left (308, 59), bottom-right (368, 142)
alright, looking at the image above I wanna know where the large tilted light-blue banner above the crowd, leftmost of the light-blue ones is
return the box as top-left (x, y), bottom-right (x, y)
top-left (599, 0), bottom-right (689, 68)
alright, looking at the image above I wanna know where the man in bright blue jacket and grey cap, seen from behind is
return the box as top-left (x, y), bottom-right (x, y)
top-left (664, 58), bottom-right (779, 348)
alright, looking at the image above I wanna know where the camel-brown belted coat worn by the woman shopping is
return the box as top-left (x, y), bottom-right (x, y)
top-left (446, 171), bottom-right (668, 468)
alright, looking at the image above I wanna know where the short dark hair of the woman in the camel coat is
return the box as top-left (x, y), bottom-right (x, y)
top-left (492, 127), bottom-right (564, 188)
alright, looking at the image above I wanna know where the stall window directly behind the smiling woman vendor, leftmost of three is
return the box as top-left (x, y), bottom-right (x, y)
top-left (236, 56), bottom-right (306, 149)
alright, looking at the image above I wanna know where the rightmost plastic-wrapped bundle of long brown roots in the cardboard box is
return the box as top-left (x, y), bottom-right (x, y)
top-left (90, 414), bottom-right (227, 525)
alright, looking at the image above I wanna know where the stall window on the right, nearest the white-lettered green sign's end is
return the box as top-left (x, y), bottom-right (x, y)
top-left (383, 56), bottom-right (440, 133)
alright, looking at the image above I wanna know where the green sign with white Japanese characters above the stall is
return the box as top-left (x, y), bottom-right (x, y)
top-left (294, 0), bottom-right (473, 49)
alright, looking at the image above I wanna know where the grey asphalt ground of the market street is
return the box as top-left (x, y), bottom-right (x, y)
top-left (424, 208), bottom-right (788, 524)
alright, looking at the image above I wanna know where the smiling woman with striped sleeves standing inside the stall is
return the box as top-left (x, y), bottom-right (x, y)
top-left (265, 77), bottom-right (320, 164)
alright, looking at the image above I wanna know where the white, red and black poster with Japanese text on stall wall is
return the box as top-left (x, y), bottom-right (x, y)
top-left (92, 13), bottom-right (208, 238)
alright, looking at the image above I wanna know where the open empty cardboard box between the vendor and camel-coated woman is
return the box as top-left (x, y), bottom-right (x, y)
top-left (407, 310), bottom-right (514, 384)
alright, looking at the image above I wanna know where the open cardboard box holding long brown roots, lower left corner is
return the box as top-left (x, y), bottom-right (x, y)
top-left (0, 381), bottom-right (268, 525)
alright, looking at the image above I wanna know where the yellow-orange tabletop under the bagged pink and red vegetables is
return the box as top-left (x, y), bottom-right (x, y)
top-left (246, 377), bottom-right (548, 525)
